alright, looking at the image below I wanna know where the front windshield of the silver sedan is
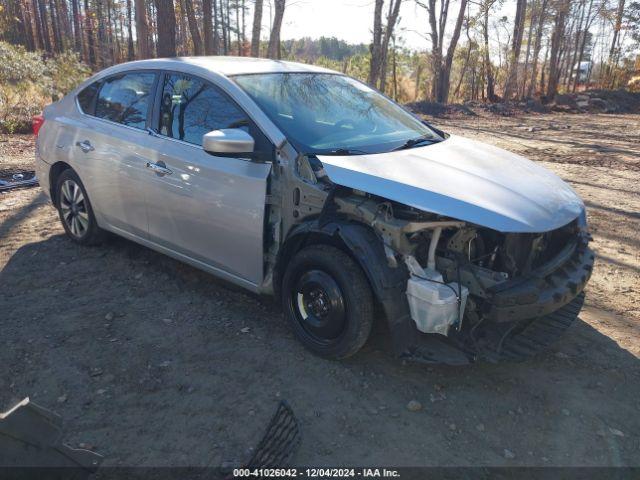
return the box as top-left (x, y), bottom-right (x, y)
top-left (234, 73), bottom-right (442, 154)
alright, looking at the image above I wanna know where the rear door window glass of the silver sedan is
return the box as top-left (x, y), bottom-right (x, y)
top-left (96, 73), bottom-right (155, 129)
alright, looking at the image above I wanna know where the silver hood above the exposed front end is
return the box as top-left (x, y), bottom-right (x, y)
top-left (318, 135), bottom-right (584, 232)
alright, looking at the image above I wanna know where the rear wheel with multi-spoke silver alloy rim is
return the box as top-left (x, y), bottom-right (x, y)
top-left (55, 169), bottom-right (106, 245)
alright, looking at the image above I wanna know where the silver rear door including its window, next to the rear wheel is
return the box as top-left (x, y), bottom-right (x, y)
top-left (71, 71), bottom-right (158, 238)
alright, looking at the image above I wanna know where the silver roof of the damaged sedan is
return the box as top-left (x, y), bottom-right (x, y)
top-left (107, 56), bottom-right (339, 76)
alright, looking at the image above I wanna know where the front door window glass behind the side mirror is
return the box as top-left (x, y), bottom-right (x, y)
top-left (159, 74), bottom-right (250, 145)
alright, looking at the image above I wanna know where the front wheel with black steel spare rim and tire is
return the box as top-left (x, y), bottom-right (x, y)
top-left (282, 245), bottom-right (373, 360)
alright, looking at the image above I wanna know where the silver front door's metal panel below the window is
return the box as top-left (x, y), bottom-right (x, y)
top-left (146, 137), bottom-right (271, 284)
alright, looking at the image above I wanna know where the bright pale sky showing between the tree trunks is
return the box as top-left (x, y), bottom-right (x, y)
top-left (262, 0), bottom-right (515, 50)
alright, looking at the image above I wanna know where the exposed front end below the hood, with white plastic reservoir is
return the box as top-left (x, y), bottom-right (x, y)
top-left (280, 154), bottom-right (593, 363)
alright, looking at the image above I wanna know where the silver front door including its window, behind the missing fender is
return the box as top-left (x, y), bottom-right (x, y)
top-left (145, 72), bottom-right (273, 285)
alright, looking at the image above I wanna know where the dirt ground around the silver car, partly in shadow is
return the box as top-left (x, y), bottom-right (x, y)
top-left (0, 110), bottom-right (640, 466)
